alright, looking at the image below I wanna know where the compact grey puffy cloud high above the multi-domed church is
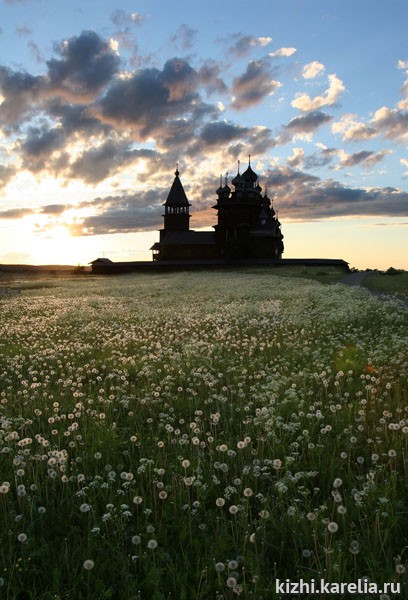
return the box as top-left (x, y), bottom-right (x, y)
top-left (231, 60), bottom-right (282, 110)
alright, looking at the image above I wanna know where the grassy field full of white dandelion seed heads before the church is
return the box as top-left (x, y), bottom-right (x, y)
top-left (0, 270), bottom-right (408, 600)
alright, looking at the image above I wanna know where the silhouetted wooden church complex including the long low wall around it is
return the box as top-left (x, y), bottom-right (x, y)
top-left (90, 157), bottom-right (349, 275)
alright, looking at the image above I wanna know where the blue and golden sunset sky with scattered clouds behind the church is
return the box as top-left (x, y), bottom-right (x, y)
top-left (0, 0), bottom-right (408, 269)
